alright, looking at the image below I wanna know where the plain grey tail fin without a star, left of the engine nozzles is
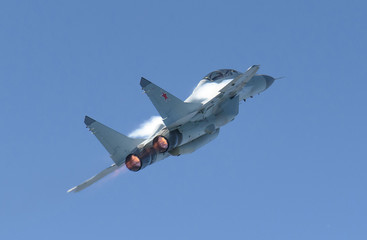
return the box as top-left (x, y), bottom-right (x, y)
top-left (84, 116), bottom-right (144, 166)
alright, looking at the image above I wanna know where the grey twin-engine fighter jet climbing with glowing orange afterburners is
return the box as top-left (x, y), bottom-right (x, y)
top-left (68, 65), bottom-right (275, 192)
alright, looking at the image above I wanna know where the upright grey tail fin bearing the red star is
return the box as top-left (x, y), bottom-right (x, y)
top-left (140, 78), bottom-right (201, 129)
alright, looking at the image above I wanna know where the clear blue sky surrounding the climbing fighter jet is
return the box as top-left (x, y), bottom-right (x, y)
top-left (0, 0), bottom-right (367, 240)
